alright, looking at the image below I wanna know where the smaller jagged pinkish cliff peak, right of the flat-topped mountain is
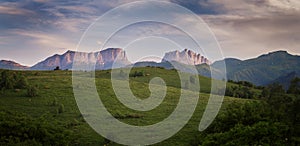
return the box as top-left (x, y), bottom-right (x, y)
top-left (162, 49), bottom-right (210, 65)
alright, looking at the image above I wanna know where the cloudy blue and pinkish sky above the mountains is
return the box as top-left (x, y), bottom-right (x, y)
top-left (0, 0), bottom-right (300, 66)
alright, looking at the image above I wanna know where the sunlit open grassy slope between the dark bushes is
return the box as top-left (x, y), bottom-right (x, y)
top-left (0, 67), bottom-right (251, 145)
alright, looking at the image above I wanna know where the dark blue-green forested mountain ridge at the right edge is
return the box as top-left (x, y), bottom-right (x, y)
top-left (211, 51), bottom-right (300, 85)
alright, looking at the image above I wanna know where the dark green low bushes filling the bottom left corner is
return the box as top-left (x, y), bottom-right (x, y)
top-left (0, 111), bottom-right (75, 145)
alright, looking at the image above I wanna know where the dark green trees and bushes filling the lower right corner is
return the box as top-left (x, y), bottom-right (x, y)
top-left (191, 78), bottom-right (300, 146)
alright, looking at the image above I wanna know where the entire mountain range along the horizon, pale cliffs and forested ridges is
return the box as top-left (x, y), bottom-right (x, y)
top-left (0, 48), bottom-right (300, 87)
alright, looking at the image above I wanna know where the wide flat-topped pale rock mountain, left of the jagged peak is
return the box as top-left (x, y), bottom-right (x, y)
top-left (31, 48), bottom-right (130, 70)
